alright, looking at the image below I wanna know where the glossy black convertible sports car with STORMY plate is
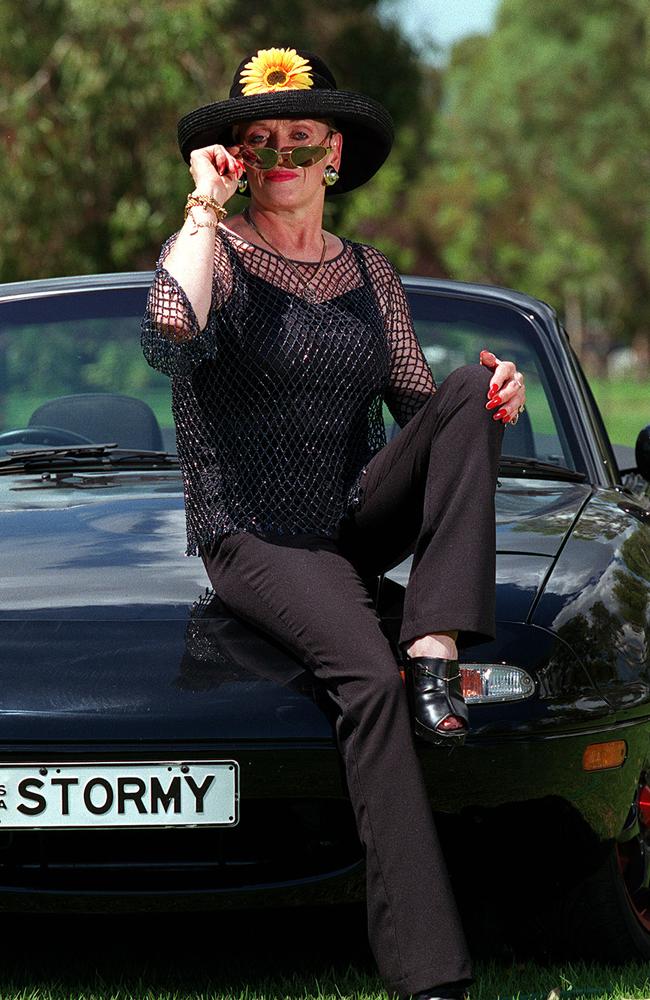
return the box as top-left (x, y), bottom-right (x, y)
top-left (0, 273), bottom-right (650, 959)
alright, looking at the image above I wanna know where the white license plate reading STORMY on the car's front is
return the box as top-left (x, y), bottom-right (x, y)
top-left (0, 760), bottom-right (239, 831)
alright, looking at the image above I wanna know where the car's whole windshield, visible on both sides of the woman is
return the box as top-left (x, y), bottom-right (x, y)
top-left (0, 287), bottom-right (576, 469)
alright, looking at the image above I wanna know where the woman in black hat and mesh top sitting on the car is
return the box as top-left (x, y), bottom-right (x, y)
top-left (143, 49), bottom-right (524, 1000)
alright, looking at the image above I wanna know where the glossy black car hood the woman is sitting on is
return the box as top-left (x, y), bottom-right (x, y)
top-left (0, 472), bottom-right (589, 743)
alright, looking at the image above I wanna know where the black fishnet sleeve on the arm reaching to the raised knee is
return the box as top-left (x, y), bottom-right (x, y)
top-left (364, 247), bottom-right (436, 427)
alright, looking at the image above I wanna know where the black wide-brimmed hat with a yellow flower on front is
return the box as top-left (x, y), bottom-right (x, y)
top-left (178, 49), bottom-right (393, 194)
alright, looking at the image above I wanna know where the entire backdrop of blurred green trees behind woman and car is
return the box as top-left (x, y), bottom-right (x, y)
top-left (5, 0), bottom-right (650, 368)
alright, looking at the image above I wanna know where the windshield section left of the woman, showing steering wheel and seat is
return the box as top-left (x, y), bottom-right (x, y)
top-left (0, 288), bottom-right (176, 454)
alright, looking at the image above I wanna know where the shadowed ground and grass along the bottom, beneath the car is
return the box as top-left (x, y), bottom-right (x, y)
top-left (0, 907), bottom-right (650, 1000)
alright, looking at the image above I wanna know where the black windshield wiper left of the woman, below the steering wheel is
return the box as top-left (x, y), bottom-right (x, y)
top-left (0, 442), bottom-right (178, 473)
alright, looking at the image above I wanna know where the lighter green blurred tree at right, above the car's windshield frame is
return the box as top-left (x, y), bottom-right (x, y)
top-left (409, 0), bottom-right (650, 374)
